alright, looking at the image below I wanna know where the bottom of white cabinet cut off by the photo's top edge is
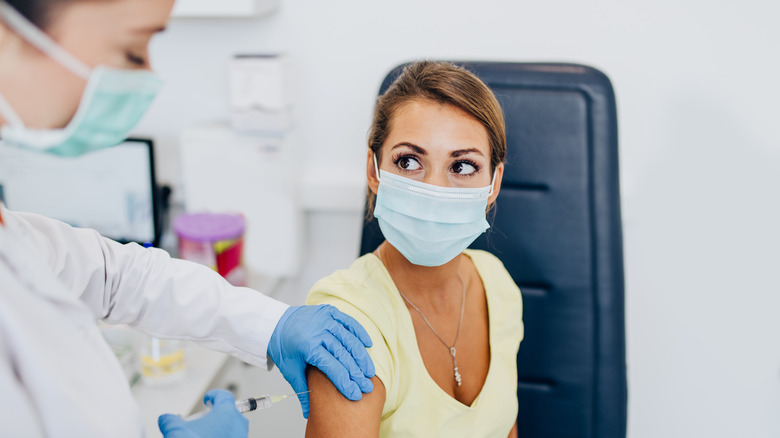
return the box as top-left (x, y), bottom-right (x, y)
top-left (173, 0), bottom-right (279, 18)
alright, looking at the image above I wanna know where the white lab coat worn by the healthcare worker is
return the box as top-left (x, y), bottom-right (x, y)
top-left (0, 206), bottom-right (288, 438)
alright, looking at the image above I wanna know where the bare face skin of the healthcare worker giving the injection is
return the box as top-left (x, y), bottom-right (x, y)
top-left (0, 0), bottom-right (174, 128)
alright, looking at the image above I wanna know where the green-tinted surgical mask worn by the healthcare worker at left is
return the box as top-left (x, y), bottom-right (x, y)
top-left (0, 1), bottom-right (162, 156)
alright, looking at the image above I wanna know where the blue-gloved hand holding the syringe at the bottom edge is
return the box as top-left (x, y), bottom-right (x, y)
top-left (157, 389), bottom-right (249, 438)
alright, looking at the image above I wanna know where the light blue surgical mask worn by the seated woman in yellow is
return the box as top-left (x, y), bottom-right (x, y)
top-left (374, 156), bottom-right (496, 266)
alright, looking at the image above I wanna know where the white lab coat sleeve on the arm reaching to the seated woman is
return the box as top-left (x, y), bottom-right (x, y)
top-left (4, 210), bottom-right (289, 367)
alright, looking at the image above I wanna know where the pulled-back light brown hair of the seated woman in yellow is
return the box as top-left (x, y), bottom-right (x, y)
top-left (368, 61), bottom-right (506, 217)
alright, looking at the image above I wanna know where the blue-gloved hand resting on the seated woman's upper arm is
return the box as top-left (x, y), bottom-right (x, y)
top-left (268, 304), bottom-right (374, 418)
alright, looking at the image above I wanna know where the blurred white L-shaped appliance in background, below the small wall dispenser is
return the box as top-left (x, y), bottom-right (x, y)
top-left (181, 123), bottom-right (303, 280)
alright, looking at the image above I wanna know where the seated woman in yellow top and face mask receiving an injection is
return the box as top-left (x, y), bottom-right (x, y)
top-left (307, 62), bottom-right (523, 437)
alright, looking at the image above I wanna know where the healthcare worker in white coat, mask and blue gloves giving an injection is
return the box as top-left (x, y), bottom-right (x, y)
top-left (0, 0), bottom-right (374, 437)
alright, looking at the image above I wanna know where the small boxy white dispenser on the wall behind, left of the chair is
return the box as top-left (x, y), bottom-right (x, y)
top-left (228, 54), bottom-right (293, 135)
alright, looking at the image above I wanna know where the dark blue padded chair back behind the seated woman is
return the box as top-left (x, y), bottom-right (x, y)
top-left (360, 62), bottom-right (627, 438)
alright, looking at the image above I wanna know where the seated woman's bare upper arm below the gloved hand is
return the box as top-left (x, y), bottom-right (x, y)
top-left (306, 367), bottom-right (386, 438)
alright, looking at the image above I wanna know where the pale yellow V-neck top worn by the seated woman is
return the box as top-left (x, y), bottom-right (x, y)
top-left (306, 250), bottom-right (523, 438)
